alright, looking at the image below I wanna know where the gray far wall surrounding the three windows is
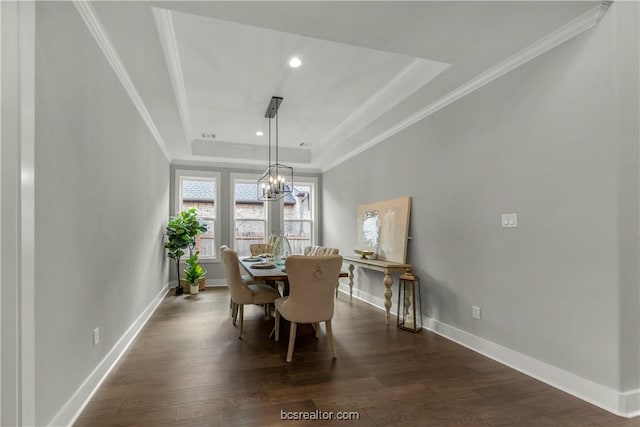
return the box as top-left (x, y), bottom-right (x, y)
top-left (169, 166), bottom-right (322, 281)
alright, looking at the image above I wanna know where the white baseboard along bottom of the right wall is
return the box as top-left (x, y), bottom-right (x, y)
top-left (339, 285), bottom-right (640, 418)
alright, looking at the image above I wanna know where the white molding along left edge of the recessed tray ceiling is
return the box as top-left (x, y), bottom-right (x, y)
top-left (152, 8), bottom-right (193, 145)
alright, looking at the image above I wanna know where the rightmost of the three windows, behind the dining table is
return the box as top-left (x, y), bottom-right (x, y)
top-left (282, 178), bottom-right (318, 254)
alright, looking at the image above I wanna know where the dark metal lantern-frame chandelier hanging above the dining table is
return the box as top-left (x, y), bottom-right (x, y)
top-left (258, 96), bottom-right (293, 201)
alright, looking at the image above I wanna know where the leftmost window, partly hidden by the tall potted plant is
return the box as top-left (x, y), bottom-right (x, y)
top-left (175, 170), bottom-right (220, 259)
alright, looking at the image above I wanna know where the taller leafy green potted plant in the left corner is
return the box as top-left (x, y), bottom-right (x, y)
top-left (164, 208), bottom-right (207, 295)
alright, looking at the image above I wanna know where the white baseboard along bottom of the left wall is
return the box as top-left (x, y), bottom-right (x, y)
top-left (47, 283), bottom-right (169, 426)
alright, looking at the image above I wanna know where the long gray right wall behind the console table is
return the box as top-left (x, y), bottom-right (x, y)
top-left (323, 2), bottom-right (640, 391)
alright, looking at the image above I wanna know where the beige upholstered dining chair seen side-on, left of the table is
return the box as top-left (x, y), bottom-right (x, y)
top-left (222, 248), bottom-right (280, 338)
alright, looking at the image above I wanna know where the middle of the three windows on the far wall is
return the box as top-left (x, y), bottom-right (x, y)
top-left (231, 174), bottom-right (268, 256)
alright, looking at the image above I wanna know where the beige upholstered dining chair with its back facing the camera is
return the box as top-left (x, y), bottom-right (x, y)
top-left (275, 255), bottom-right (342, 362)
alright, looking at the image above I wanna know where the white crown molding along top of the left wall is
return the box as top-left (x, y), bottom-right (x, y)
top-left (73, 0), bottom-right (171, 162)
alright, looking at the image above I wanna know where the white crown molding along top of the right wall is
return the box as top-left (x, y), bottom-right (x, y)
top-left (321, 1), bottom-right (611, 172)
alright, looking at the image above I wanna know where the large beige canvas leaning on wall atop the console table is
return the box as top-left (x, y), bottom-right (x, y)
top-left (356, 197), bottom-right (411, 263)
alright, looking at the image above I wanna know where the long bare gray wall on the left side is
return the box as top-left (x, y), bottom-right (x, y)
top-left (35, 2), bottom-right (169, 425)
